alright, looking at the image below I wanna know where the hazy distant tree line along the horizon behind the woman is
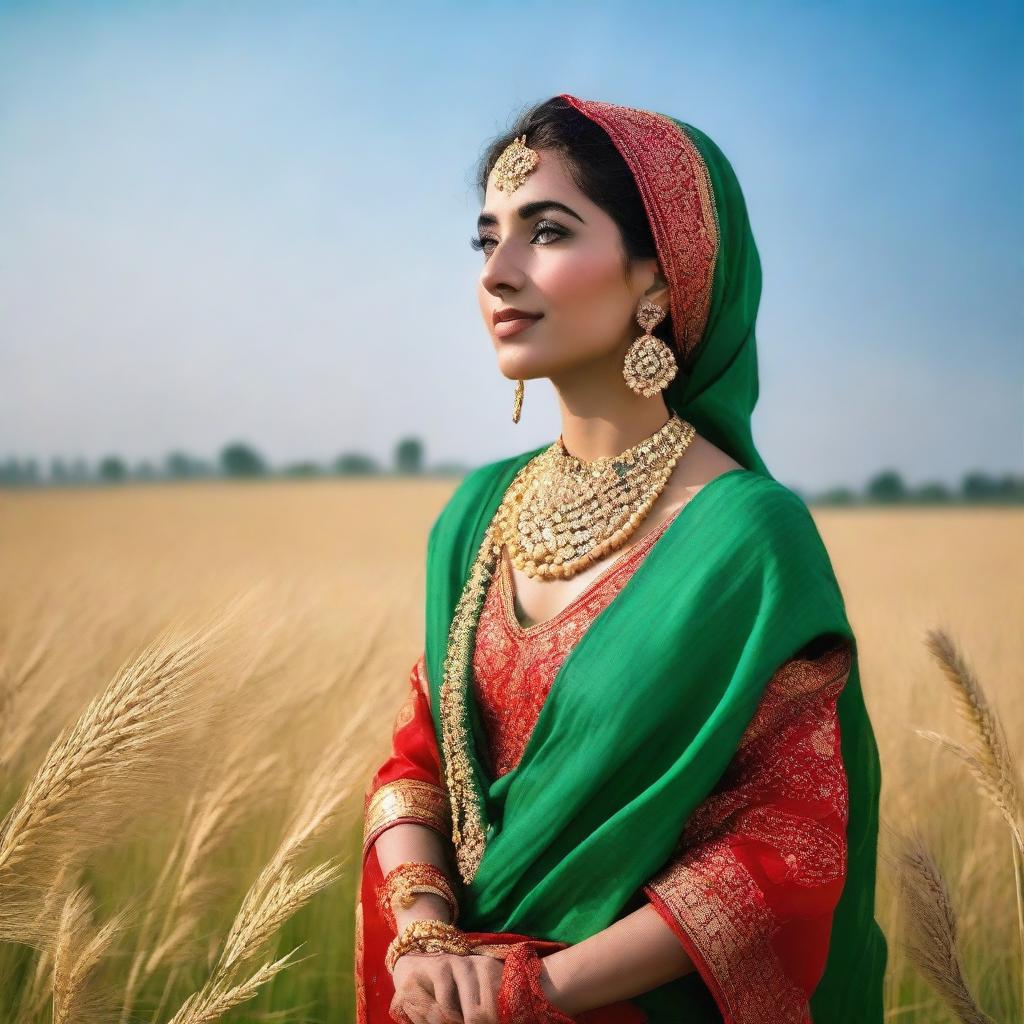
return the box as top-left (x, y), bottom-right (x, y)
top-left (0, 437), bottom-right (1024, 505)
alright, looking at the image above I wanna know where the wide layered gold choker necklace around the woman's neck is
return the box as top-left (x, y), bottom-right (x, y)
top-left (492, 413), bottom-right (696, 580)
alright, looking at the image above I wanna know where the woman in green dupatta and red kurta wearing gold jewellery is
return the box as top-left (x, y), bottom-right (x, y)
top-left (356, 93), bottom-right (887, 1024)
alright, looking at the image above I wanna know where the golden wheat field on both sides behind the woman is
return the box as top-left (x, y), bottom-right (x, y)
top-left (0, 478), bottom-right (1024, 1024)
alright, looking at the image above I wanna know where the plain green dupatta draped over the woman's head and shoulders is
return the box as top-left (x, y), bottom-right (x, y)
top-left (426, 97), bottom-right (887, 1024)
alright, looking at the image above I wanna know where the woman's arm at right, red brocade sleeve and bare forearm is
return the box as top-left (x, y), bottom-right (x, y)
top-left (541, 638), bottom-right (851, 1024)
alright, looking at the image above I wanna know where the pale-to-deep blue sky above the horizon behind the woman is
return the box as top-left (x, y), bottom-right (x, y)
top-left (0, 0), bottom-right (1024, 488)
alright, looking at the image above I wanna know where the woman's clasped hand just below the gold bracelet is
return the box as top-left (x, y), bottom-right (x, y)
top-left (389, 952), bottom-right (503, 1024)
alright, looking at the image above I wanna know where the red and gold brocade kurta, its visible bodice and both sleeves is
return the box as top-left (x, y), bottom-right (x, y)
top-left (355, 503), bottom-right (851, 1024)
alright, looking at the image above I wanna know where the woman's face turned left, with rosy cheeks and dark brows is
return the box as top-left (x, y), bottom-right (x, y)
top-left (477, 150), bottom-right (658, 383)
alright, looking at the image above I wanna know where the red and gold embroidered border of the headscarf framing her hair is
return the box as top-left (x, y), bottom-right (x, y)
top-left (561, 92), bottom-right (720, 358)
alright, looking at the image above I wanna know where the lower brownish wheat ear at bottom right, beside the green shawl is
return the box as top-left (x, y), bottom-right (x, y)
top-left (886, 829), bottom-right (994, 1024)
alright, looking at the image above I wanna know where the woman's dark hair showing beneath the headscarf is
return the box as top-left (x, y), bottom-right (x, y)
top-left (476, 96), bottom-right (676, 349)
